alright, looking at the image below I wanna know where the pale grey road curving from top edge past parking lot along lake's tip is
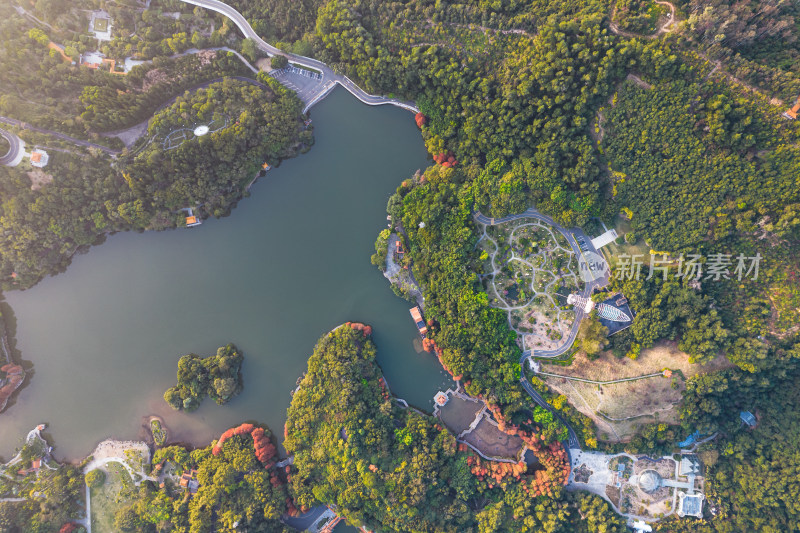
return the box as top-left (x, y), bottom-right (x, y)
top-left (181, 0), bottom-right (419, 113)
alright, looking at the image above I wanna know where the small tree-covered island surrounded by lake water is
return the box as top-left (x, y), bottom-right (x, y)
top-left (164, 344), bottom-right (244, 411)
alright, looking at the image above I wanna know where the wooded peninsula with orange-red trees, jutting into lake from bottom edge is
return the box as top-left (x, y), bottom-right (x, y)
top-left (284, 324), bottom-right (624, 533)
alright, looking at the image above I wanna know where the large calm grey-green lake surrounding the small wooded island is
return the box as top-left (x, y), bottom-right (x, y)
top-left (0, 89), bottom-right (452, 459)
